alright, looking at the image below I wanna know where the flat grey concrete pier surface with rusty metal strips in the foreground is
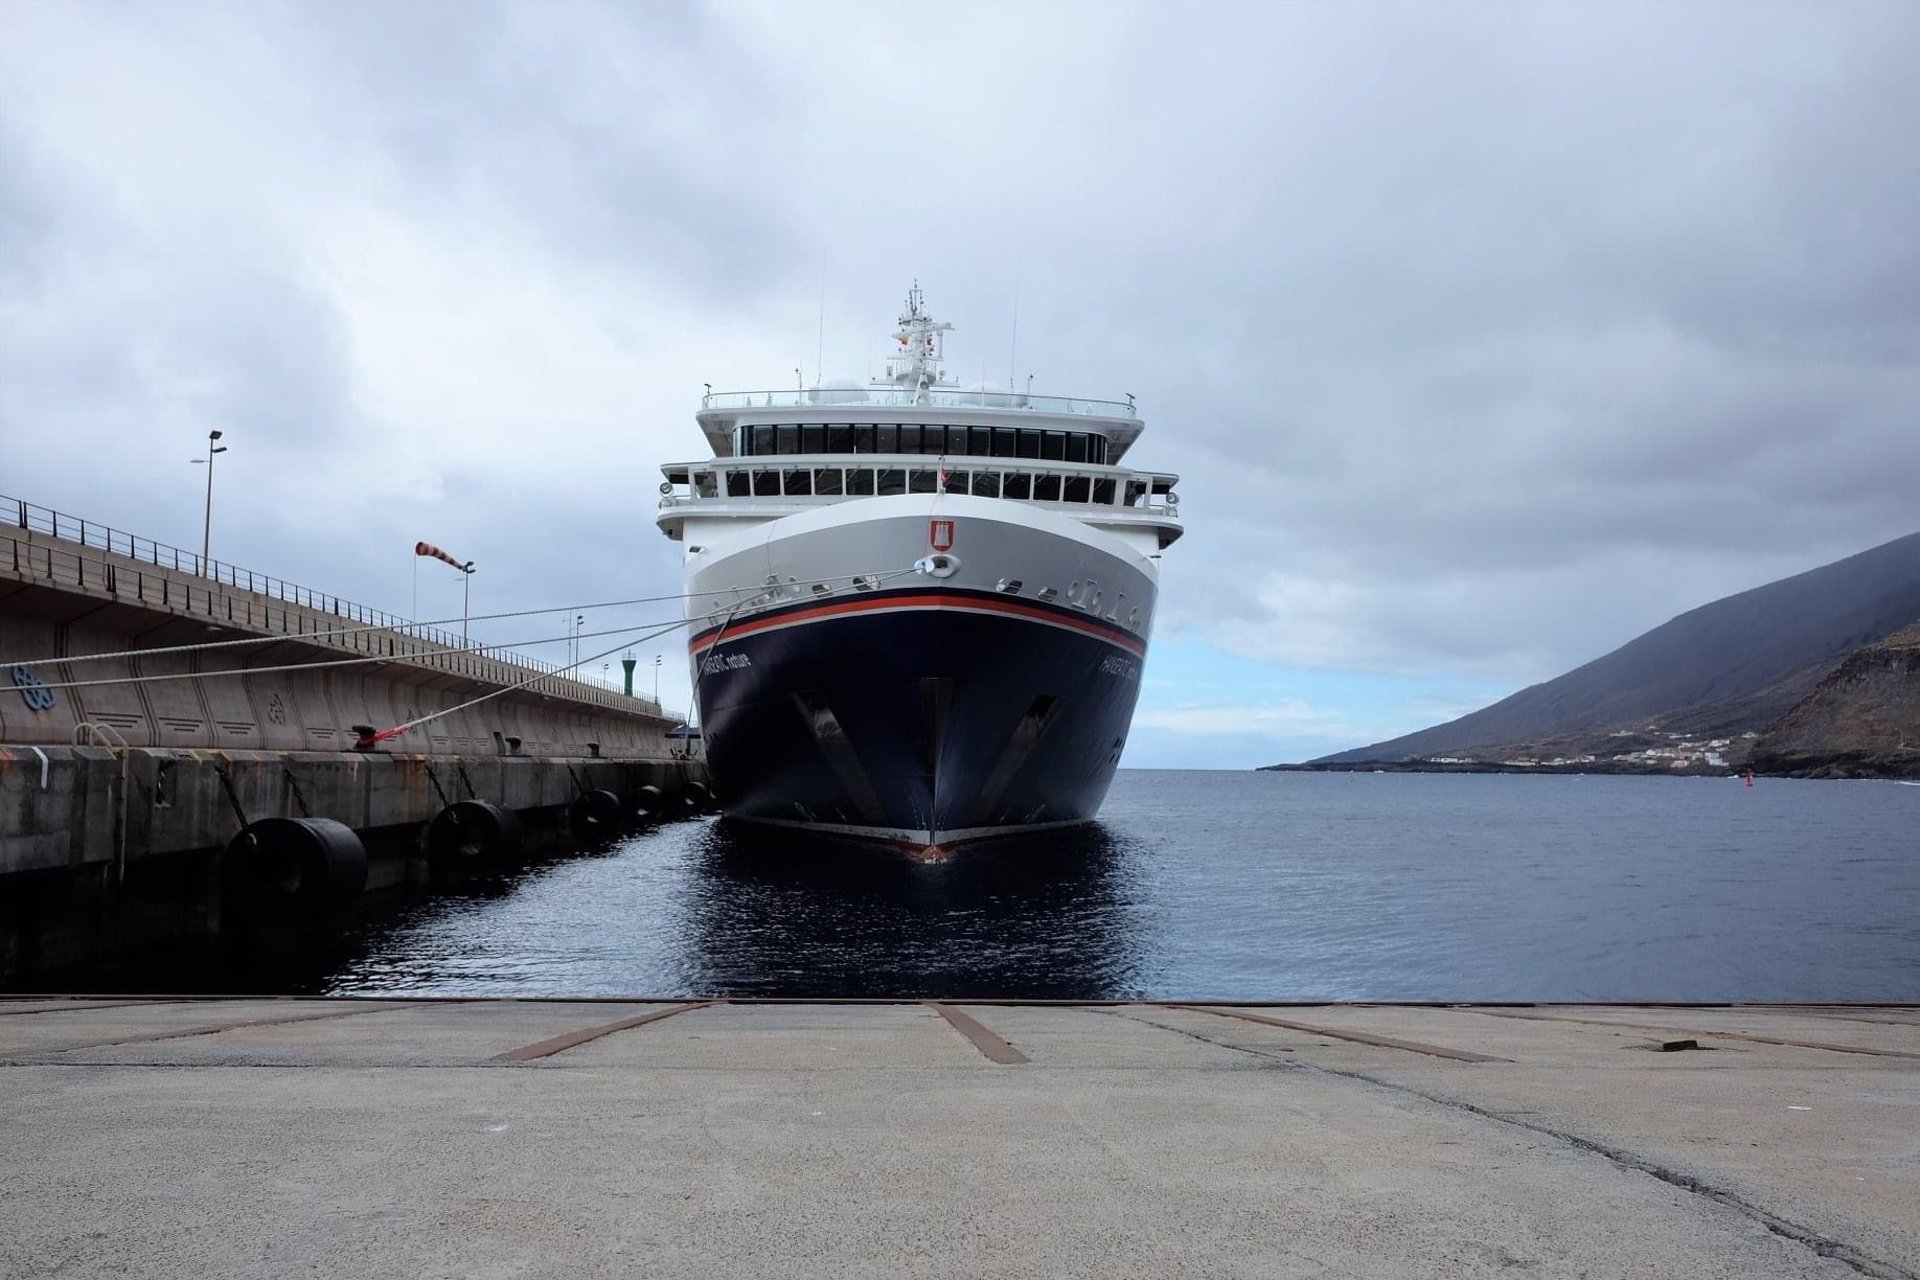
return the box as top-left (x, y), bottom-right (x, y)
top-left (0, 1000), bottom-right (1920, 1280)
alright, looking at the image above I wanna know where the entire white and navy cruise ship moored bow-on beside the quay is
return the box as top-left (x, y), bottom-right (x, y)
top-left (657, 284), bottom-right (1181, 858)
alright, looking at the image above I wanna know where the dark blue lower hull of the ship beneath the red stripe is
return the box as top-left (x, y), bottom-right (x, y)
top-left (693, 589), bottom-right (1144, 846)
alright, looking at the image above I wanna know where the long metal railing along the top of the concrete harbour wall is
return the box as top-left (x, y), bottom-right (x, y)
top-left (0, 495), bottom-right (660, 714)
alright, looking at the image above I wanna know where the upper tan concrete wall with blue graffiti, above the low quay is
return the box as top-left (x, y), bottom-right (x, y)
top-left (0, 528), bottom-right (678, 758)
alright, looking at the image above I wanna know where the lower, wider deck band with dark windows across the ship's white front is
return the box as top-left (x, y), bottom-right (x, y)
top-left (660, 453), bottom-right (1181, 520)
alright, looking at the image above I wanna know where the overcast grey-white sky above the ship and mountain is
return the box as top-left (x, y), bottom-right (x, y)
top-left (0, 0), bottom-right (1920, 766)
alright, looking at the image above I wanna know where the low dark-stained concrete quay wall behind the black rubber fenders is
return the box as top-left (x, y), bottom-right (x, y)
top-left (0, 747), bottom-right (705, 986)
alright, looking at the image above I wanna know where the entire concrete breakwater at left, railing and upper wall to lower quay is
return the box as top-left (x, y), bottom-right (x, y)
top-left (0, 499), bottom-right (705, 986)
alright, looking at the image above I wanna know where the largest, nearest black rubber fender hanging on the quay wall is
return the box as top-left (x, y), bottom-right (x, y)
top-left (225, 818), bottom-right (367, 921)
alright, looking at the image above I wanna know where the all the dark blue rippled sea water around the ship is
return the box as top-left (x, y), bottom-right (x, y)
top-left (307, 770), bottom-right (1920, 1002)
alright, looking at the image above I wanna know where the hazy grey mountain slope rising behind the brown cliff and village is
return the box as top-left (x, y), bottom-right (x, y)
top-left (1317, 533), bottom-right (1920, 764)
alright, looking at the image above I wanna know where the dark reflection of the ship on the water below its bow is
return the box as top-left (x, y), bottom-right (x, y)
top-left (680, 821), bottom-right (1144, 1000)
